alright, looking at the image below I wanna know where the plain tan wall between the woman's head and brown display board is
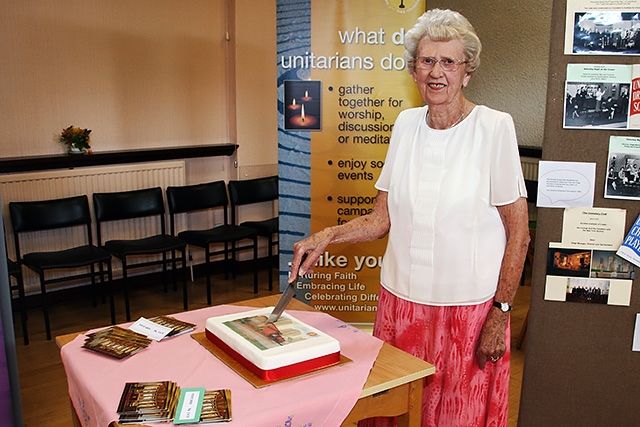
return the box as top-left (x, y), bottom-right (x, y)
top-left (427, 0), bottom-right (552, 147)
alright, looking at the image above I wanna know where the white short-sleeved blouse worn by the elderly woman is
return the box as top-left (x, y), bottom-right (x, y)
top-left (376, 106), bottom-right (527, 305)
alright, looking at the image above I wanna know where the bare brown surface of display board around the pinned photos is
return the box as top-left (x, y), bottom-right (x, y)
top-left (518, 0), bottom-right (640, 427)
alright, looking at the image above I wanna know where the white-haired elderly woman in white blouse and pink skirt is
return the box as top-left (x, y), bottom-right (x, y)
top-left (292, 9), bottom-right (529, 426)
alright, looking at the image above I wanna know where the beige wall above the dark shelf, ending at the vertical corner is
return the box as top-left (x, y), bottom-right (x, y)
top-left (0, 0), bottom-right (229, 157)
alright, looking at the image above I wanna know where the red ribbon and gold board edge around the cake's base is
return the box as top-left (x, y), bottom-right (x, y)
top-left (191, 332), bottom-right (351, 388)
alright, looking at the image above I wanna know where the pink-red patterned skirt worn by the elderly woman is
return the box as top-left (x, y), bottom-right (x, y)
top-left (359, 286), bottom-right (511, 427)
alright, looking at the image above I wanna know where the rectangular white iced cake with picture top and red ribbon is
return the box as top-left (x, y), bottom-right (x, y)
top-left (205, 307), bottom-right (340, 381)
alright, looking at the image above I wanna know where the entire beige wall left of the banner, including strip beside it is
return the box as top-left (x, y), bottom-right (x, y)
top-left (0, 0), bottom-right (277, 183)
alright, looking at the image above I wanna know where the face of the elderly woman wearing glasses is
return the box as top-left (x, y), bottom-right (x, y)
top-left (413, 37), bottom-right (471, 108)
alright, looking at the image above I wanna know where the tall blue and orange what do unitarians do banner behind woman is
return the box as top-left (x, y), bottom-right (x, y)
top-left (277, 0), bottom-right (425, 323)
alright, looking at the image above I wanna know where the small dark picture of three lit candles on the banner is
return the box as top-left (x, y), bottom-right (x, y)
top-left (284, 80), bottom-right (322, 131)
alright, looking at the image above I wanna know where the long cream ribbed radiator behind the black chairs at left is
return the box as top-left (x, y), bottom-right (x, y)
top-left (0, 161), bottom-right (185, 293)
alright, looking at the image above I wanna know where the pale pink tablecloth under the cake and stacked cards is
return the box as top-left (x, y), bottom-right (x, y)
top-left (62, 305), bottom-right (382, 427)
